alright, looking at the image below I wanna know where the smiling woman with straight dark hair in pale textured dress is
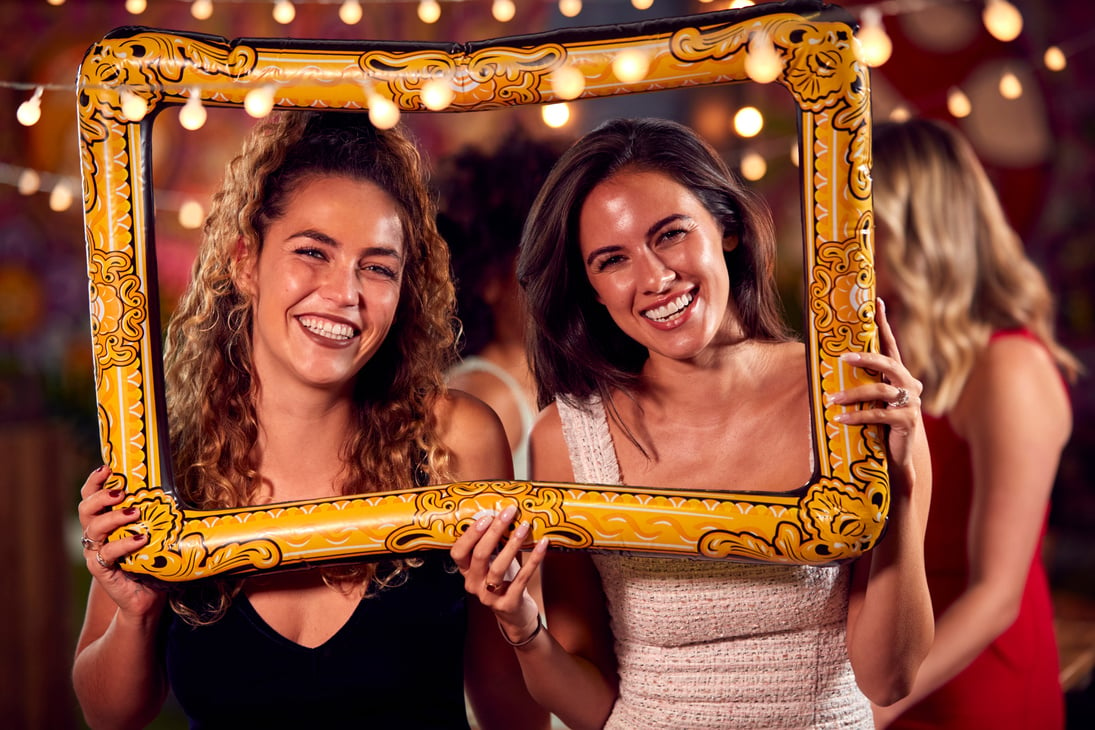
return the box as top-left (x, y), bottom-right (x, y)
top-left (451, 119), bottom-right (932, 730)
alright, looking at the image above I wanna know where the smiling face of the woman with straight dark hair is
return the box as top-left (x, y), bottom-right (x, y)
top-left (578, 170), bottom-right (736, 359)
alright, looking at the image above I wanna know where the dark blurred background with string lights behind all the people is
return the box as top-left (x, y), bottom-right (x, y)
top-left (0, 0), bottom-right (1095, 729)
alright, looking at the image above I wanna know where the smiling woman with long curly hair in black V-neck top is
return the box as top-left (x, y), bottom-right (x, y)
top-left (73, 112), bottom-right (544, 728)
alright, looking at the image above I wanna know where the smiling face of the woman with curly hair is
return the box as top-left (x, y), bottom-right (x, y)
top-left (241, 175), bottom-right (405, 392)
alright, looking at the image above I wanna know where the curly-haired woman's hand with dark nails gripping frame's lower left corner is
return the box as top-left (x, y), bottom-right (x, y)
top-left (77, 466), bottom-right (164, 616)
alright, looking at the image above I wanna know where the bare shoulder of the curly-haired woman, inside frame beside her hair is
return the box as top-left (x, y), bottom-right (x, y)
top-left (434, 390), bottom-right (514, 480)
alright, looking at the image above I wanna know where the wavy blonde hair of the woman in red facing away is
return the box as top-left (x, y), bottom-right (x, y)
top-left (873, 119), bottom-right (1080, 415)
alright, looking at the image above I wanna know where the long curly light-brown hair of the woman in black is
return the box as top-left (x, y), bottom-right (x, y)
top-left (164, 112), bottom-right (456, 617)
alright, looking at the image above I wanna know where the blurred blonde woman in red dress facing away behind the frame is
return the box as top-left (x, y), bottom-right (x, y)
top-left (873, 119), bottom-right (1079, 730)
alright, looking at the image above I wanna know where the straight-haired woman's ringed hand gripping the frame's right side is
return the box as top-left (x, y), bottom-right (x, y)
top-left (829, 299), bottom-right (924, 464)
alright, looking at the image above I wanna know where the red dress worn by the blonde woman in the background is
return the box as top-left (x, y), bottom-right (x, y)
top-left (891, 333), bottom-right (1064, 730)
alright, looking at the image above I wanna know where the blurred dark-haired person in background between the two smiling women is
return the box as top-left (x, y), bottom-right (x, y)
top-left (438, 127), bottom-right (563, 479)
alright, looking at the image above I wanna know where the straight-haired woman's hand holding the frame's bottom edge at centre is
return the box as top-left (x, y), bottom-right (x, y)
top-left (450, 505), bottom-right (548, 642)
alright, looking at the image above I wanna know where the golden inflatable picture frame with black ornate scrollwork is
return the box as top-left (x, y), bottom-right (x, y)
top-left (78, 0), bottom-right (889, 581)
